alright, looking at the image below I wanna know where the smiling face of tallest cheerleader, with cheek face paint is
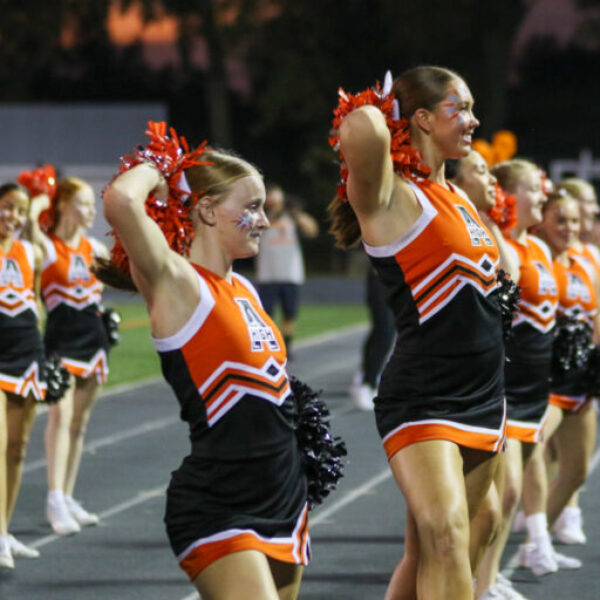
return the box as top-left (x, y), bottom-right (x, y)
top-left (430, 79), bottom-right (479, 158)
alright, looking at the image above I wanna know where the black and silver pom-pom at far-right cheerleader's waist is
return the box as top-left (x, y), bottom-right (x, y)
top-left (552, 315), bottom-right (594, 373)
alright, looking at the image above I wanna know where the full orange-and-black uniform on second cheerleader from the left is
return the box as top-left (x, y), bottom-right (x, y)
top-left (42, 234), bottom-right (109, 383)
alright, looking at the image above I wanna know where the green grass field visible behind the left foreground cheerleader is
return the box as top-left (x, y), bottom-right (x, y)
top-left (107, 304), bottom-right (368, 387)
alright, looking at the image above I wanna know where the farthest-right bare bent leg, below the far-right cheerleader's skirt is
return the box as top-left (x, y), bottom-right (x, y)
top-left (547, 403), bottom-right (596, 527)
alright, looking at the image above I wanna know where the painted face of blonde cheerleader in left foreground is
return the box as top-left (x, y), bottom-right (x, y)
top-left (214, 175), bottom-right (269, 259)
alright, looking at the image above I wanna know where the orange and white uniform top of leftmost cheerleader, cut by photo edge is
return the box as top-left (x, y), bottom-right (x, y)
top-left (0, 240), bottom-right (38, 325)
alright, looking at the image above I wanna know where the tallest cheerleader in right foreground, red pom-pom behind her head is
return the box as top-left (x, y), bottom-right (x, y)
top-left (330, 67), bottom-right (505, 600)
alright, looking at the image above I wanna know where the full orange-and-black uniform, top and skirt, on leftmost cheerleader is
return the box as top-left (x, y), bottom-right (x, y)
top-left (0, 240), bottom-right (46, 400)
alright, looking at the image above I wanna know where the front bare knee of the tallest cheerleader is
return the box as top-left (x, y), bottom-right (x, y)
top-left (416, 507), bottom-right (469, 560)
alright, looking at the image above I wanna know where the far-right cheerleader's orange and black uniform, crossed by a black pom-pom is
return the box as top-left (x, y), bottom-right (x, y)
top-left (550, 250), bottom-right (598, 412)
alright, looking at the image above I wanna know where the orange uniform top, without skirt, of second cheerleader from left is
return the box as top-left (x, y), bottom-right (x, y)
top-left (42, 234), bottom-right (102, 312)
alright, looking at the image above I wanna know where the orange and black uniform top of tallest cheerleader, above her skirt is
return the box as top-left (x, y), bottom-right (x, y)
top-left (364, 178), bottom-right (502, 355)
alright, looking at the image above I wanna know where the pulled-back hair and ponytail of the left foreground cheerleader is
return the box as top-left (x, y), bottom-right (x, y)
top-left (92, 149), bottom-right (260, 292)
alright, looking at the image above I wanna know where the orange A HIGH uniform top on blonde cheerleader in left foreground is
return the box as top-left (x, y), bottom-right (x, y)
top-left (154, 265), bottom-right (293, 458)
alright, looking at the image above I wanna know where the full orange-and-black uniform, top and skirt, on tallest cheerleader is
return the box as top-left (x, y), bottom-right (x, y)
top-left (364, 178), bottom-right (506, 458)
